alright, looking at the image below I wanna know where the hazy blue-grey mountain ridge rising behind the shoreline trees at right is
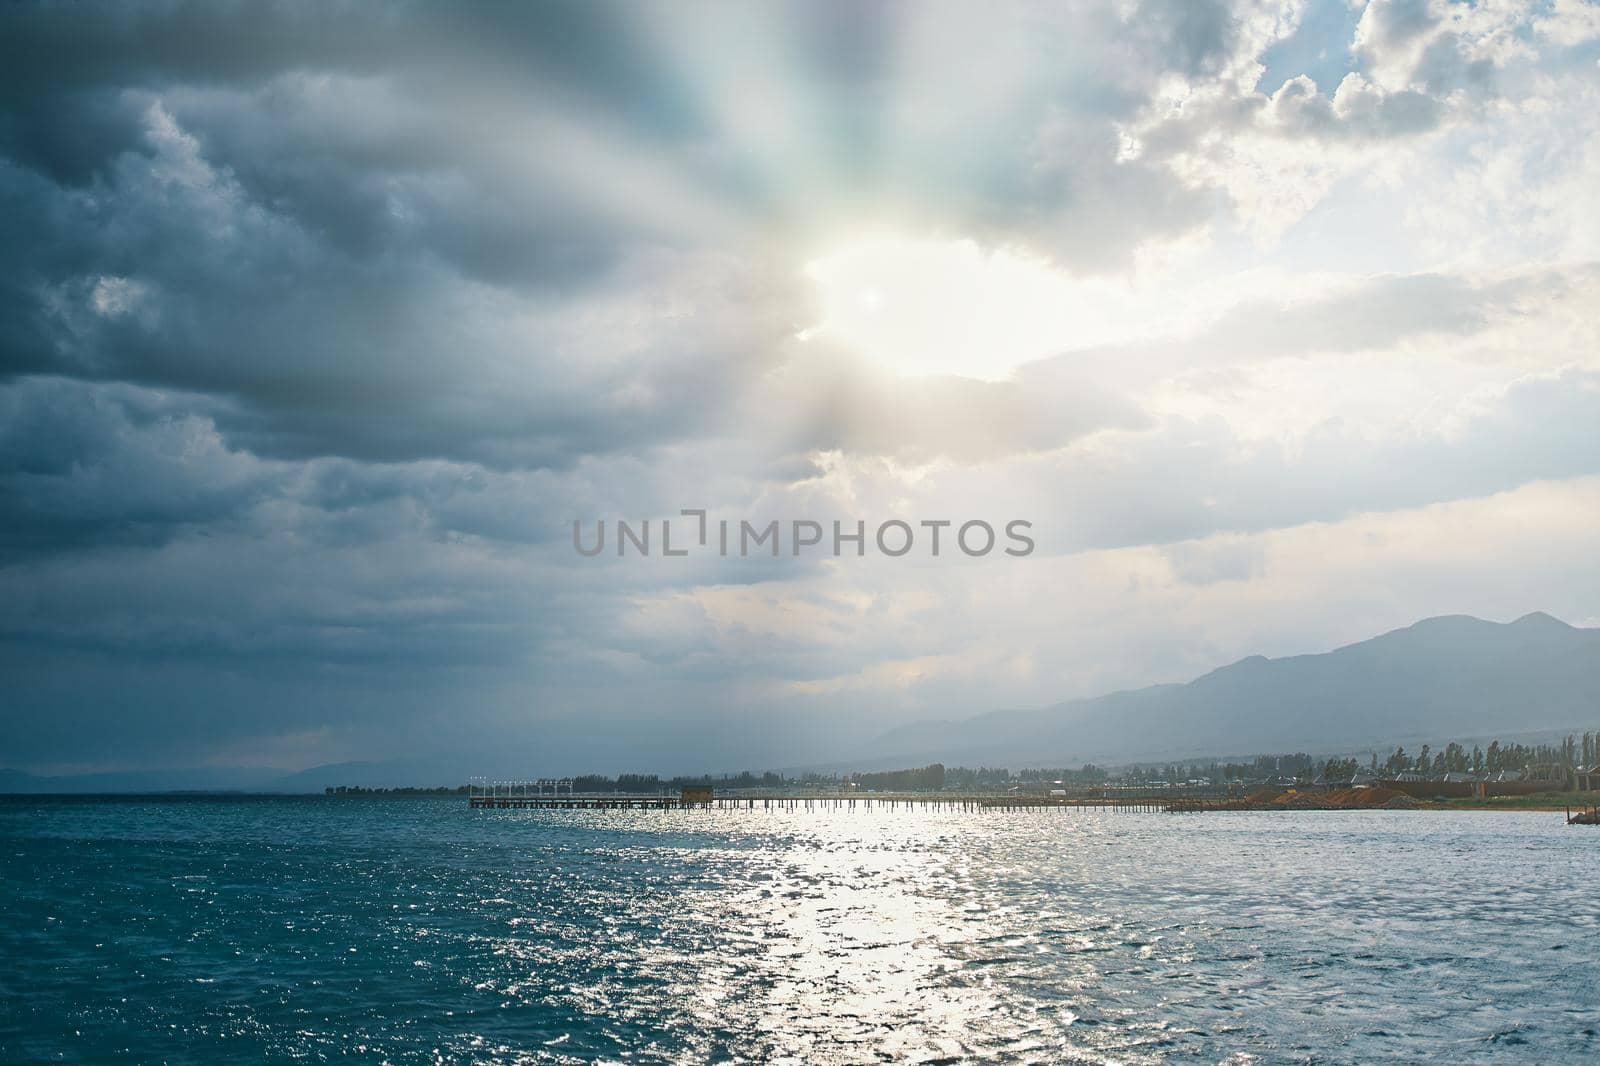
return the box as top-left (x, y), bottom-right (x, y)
top-left (861, 613), bottom-right (1600, 767)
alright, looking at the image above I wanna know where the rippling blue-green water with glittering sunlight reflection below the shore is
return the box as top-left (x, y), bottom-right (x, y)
top-left (0, 797), bottom-right (1600, 1063)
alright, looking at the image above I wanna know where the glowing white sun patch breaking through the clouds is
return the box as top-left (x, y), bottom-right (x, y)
top-left (802, 237), bottom-right (1126, 381)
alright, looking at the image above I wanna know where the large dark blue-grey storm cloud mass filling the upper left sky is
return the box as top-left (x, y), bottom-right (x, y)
top-left (0, 3), bottom-right (802, 466)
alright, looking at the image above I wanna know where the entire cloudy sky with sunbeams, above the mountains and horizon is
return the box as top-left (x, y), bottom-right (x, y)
top-left (0, 0), bottom-right (1600, 775)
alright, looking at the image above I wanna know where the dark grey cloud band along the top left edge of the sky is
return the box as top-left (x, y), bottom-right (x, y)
top-left (0, 0), bottom-right (698, 181)
